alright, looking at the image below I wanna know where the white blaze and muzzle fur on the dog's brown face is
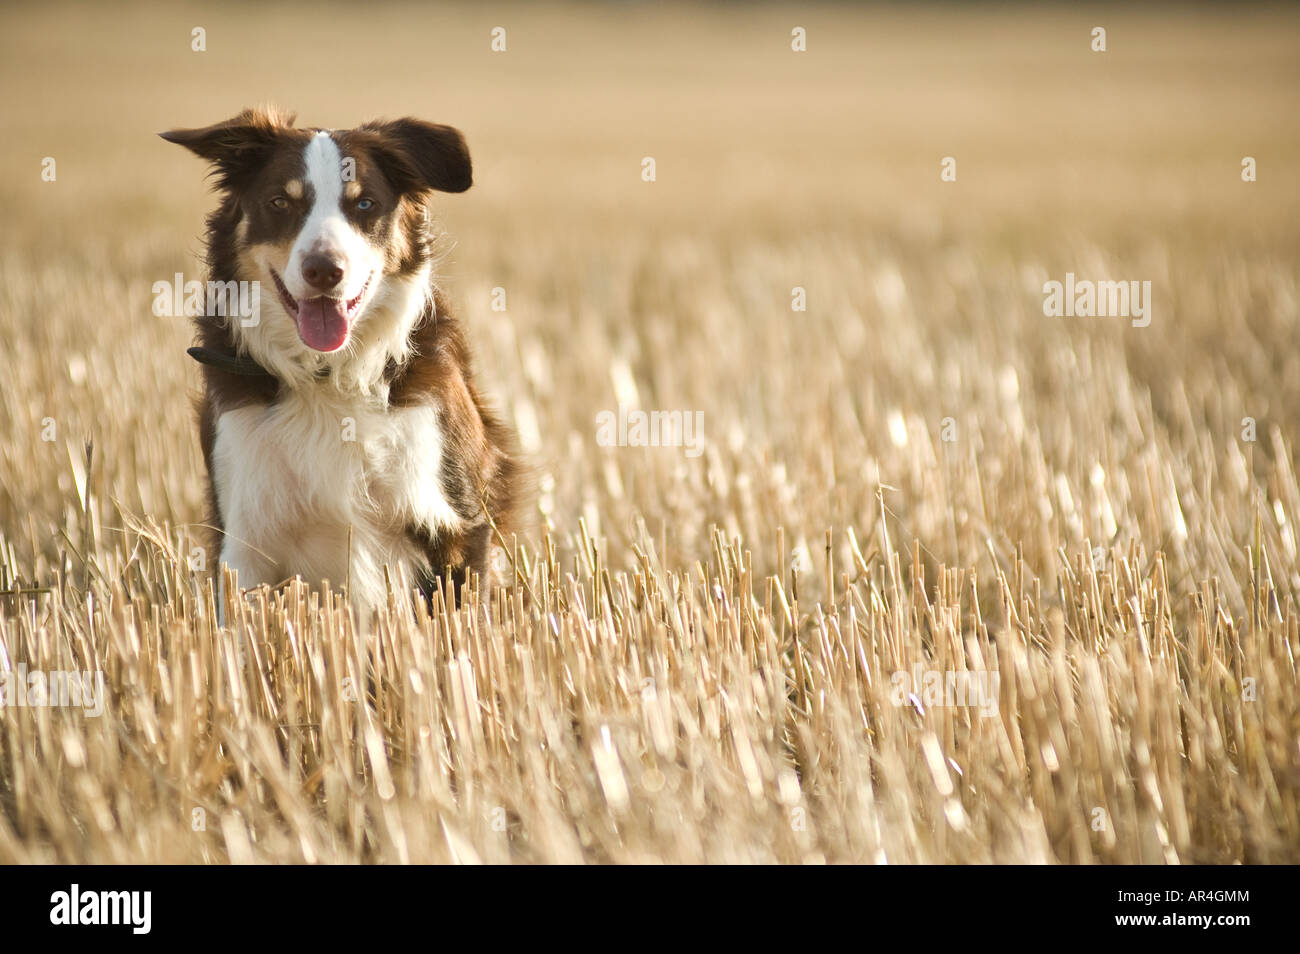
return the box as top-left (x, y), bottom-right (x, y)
top-left (283, 133), bottom-right (384, 302)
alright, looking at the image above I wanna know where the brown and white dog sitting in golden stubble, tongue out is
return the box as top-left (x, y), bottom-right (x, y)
top-left (161, 108), bottom-right (520, 608)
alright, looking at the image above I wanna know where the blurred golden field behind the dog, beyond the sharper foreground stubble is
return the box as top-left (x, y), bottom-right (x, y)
top-left (0, 3), bottom-right (1300, 597)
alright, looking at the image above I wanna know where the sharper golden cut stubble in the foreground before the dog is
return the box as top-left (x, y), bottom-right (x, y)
top-left (0, 509), bottom-right (1300, 863)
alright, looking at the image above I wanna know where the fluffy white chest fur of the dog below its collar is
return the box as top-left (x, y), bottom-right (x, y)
top-left (212, 393), bottom-right (460, 604)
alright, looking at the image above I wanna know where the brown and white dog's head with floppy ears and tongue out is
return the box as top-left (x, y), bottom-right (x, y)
top-left (161, 108), bottom-right (472, 389)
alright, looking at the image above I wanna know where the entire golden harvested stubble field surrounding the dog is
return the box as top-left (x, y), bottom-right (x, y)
top-left (0, 4), bottom-right (1300, 863)
